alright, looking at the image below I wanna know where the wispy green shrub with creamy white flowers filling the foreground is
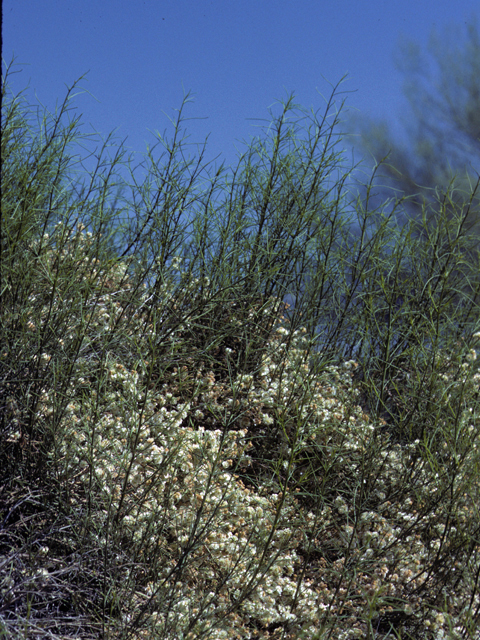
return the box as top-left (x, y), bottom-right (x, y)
top-left (0, 60), bottom-right (480, 640)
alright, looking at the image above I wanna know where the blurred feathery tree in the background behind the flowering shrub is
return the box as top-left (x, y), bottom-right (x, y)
top-left (351, 19), bottom-right (480, 222)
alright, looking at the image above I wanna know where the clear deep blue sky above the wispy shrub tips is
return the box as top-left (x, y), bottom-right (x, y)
top-left (2, 0), bottom-right (479, 172)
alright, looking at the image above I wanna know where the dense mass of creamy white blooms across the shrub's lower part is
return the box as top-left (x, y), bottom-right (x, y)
top-left (29, 230), bottom-right (480, 640)
